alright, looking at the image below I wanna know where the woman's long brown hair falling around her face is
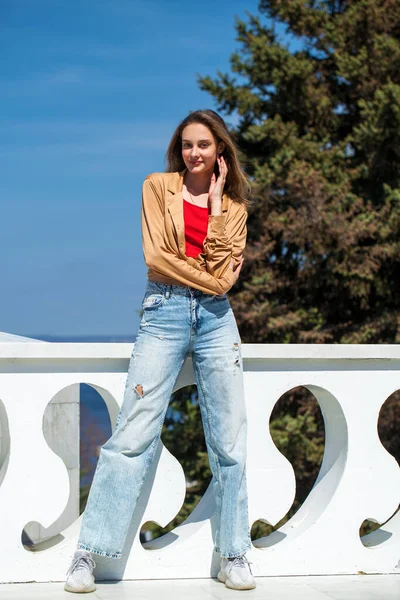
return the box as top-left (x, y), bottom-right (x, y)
top-left (166, 109), bottom-right (250, 204)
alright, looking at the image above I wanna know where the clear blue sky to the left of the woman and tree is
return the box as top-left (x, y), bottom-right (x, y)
top-left (0, 0), bottom-right (258, 338)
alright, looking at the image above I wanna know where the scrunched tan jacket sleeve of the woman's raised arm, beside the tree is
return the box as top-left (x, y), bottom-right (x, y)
top-left (203, 203), bottom-right (247, 277)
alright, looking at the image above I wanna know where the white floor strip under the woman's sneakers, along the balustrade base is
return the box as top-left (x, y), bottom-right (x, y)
top-left (0, 575), bottom-right (400, 600)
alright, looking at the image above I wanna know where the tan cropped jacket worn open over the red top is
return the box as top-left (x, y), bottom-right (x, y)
top-left (142, 169), bottom-right (247, 294)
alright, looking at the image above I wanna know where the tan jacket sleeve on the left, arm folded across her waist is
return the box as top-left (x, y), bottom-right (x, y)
top-left (142, 178), bottom-right (235, 294)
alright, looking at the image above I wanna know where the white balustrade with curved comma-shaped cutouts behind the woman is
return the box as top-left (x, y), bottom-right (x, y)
top-left (0, 343), bottom-right (400, 582)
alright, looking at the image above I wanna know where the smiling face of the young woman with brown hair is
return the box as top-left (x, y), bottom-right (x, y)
top-left (182, 123), bottom-right (217, 176)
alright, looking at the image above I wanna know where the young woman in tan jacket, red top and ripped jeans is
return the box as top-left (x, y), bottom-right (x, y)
top-left (65, 110), bottom-right (255, 592)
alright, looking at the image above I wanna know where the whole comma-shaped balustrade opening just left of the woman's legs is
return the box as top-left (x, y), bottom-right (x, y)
top-left (21, 383), bottom-right (119, 552)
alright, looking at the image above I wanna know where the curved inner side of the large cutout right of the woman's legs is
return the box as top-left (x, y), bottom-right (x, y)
top-left (253, 384), bottom-right (348, 548)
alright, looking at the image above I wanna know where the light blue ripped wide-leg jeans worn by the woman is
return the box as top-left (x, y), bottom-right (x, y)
top-left (78, 281), bottom-right (251, 558)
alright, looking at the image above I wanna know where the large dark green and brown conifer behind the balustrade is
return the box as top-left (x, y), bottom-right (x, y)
top-left (199, 0), bottom-right (400, 343)
